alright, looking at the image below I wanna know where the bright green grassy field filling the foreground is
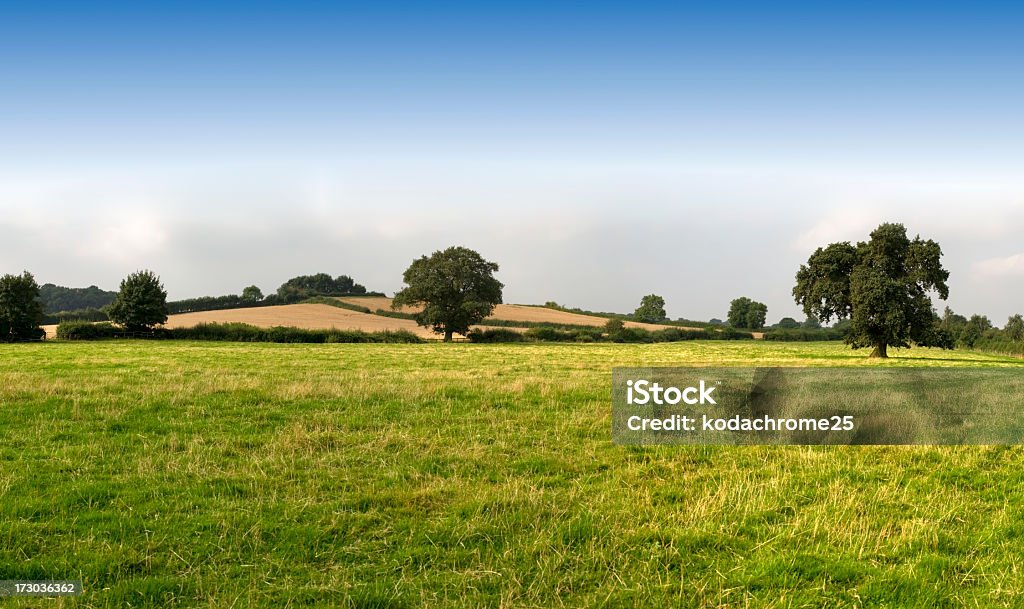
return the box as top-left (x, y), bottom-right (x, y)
top-left (0, 342), bottom-right (1024, 607)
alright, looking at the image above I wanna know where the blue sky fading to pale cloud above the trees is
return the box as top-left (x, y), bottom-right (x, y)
top-left (0, 2), bottom-right (1024, 323)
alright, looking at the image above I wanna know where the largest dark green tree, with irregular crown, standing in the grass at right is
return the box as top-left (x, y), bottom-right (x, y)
top-left (793, 223), bottom-right (949, 357)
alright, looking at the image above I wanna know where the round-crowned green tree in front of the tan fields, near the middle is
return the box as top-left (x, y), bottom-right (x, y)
top-left (391, 247), bottom-right (505, 342)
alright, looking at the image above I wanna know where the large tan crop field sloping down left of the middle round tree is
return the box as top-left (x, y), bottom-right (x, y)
top-left (167, 304), bottom-right (517, 339)
